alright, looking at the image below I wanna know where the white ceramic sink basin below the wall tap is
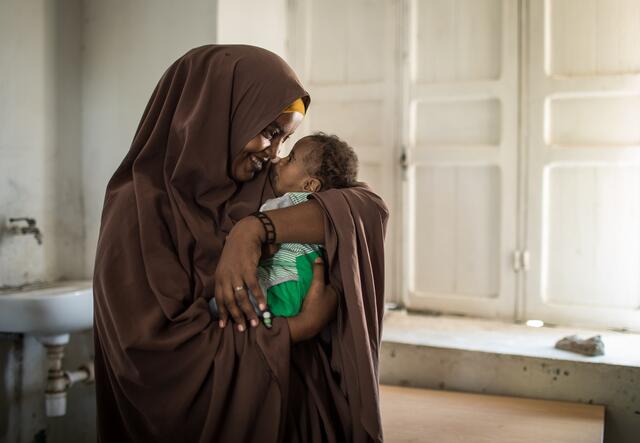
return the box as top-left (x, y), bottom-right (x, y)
top-left (0, 280), bottom-right (93, 335)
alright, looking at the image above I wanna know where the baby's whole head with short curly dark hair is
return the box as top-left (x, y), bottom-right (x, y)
top-left (273, 132), bottom-right (358, 195)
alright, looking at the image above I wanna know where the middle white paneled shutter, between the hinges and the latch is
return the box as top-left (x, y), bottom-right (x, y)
top-left (403, 0), bottom-right (518, 319)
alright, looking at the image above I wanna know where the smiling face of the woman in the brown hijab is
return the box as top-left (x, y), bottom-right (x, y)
top-left (231, 112), bottom-right (303, 182)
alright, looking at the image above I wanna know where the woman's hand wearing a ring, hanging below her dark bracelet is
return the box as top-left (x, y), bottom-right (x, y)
top-left (215, 217), bottom-right (267, 332)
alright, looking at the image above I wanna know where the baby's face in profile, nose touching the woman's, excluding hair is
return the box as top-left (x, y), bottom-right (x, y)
top-left (271, 138), bottom-right (320, 195)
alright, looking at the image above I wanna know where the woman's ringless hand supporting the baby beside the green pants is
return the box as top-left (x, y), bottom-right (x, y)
top-left (287, 258), bottom-right (338, 343)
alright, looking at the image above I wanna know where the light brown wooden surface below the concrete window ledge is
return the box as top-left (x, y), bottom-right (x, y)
top-left (380, 386), bottom-right (604, 443)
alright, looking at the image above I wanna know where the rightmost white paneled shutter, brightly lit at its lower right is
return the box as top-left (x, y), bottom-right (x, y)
top-left (525, 0), bottom-right (640, 329)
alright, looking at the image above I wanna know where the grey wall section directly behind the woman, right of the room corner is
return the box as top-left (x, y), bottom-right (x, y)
top-left (82, 0), bottom-right (216, 276)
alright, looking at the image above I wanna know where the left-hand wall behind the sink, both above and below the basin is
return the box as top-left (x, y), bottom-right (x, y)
top-left (0, 0), bottom-right (84, 442)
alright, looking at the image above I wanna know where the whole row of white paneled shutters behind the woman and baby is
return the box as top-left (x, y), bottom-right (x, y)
top-left (287, 0), bottom-right (640, 330)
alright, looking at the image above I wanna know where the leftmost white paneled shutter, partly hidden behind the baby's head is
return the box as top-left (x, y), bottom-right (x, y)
top-left (288, 0), bottom-right (401, 301)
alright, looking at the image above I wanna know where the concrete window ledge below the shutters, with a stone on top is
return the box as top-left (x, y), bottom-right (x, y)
top-left (380, 311), bottom-right (640, 443)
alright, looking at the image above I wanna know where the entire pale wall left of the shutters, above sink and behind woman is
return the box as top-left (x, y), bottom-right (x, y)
top-left (0, 0), bottom-right (287, 286)
